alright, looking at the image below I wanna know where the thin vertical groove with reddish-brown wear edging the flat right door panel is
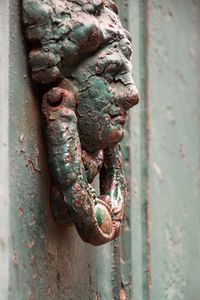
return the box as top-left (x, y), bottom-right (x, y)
top-left (139, 0), bottom-right (151, 300)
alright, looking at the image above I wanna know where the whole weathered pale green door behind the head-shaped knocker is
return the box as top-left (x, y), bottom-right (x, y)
top-left (0, 0), bottom-right (200, 300)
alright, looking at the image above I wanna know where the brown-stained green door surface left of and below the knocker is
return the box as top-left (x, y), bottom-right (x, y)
top-left (7, 0), bottom-right (117, 300)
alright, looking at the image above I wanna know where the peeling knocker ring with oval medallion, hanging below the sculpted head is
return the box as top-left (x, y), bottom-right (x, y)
top-left (42, 87), bottom-right (127, 245)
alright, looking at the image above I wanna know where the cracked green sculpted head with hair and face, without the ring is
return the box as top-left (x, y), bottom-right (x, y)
top-left (24, 0), bottom-right (139, 152)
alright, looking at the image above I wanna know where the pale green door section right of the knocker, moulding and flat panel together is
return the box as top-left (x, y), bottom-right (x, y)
top-left (129, 0), bottom-right (200, 300)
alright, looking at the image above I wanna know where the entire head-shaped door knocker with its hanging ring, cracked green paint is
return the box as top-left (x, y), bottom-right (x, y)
top-left (23, 0), bottom-right (139, 245)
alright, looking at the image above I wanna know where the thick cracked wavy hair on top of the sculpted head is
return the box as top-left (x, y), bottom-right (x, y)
top-left (23, 0), bottom-right (131, 84)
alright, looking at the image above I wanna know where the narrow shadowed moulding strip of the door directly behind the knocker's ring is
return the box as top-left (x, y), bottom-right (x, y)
top-left (113, 0), bottom-right (132, 300)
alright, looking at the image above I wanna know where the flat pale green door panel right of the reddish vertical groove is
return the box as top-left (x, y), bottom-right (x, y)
top-left (147, 0), bottom-right (200, 300)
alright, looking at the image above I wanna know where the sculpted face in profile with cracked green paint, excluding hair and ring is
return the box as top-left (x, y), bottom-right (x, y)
top-left (75, 43), bottom-right (139, 151)
